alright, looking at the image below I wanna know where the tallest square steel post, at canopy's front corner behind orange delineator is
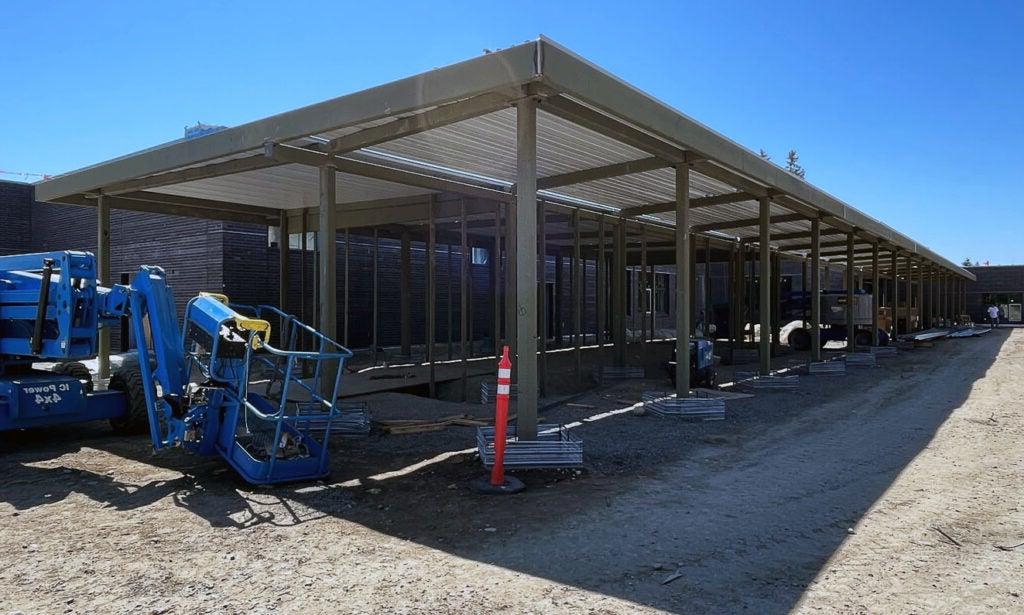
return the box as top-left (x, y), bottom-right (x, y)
top-left (513, 98), bottom-right (538, 440)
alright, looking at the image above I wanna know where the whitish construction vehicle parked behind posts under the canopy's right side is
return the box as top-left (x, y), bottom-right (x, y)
top-left (788, 291), bottom-right (889, 350)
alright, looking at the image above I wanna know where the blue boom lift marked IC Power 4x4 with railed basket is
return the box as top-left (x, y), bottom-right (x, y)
top-left (0, 252), bottom-right (351, 484)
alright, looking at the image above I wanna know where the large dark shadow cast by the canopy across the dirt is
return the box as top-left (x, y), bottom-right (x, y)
top-left (0, 331), bottom-right (1010, 613)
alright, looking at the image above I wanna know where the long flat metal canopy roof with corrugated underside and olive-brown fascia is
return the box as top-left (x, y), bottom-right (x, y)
top-left (36, 37), bottom-right (974, 279)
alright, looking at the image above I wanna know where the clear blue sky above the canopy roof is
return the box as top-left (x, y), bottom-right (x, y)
top-left (0, 0), bottom-right (1024, 264)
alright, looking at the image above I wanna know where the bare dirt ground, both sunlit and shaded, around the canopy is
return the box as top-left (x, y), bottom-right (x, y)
top-left (0, 330), bottom-right (1024, 614)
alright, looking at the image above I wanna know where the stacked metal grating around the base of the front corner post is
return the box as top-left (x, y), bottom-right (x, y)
top-left (476, 424), bottom-right (583, 469)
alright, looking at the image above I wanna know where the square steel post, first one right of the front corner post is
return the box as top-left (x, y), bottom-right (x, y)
top-left (676, 164), bottom-right (691, 397)
